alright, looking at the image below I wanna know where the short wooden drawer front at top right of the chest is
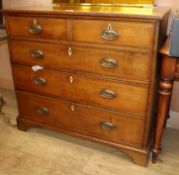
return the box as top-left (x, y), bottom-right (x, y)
top-left (72, 19), bottom-right (154, 48)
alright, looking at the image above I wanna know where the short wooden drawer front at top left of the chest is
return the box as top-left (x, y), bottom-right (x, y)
top-left (7, 16), bottom-right (67, 40)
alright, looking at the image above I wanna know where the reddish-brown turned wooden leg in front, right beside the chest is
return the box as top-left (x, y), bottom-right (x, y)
top-left (152, 55), bottom-right (176, 163)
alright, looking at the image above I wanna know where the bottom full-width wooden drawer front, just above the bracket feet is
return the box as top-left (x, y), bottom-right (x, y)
top-left (17, 92), bottom-right (144, 147)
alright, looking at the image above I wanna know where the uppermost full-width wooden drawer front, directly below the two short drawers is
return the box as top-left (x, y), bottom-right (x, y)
top-left (10, 40), bottom-right (151, 81)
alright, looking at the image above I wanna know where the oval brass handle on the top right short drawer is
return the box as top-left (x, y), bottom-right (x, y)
top-left (101, 24), bottom-right (119, 41)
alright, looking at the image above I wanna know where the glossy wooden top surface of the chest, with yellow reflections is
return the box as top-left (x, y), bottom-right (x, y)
top-left (2, 5), bottom-right (170, 20)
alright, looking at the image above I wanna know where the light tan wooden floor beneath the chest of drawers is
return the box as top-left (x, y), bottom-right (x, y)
top-left (0, 90), bottom-right (179, 175)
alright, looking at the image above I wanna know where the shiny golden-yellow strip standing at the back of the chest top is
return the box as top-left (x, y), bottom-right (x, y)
top-left (53, 0), bottom-right (154, 6)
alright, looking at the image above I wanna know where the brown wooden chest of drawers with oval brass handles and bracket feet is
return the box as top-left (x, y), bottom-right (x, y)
top-left (4, 7), bottom-right (168, 165)
